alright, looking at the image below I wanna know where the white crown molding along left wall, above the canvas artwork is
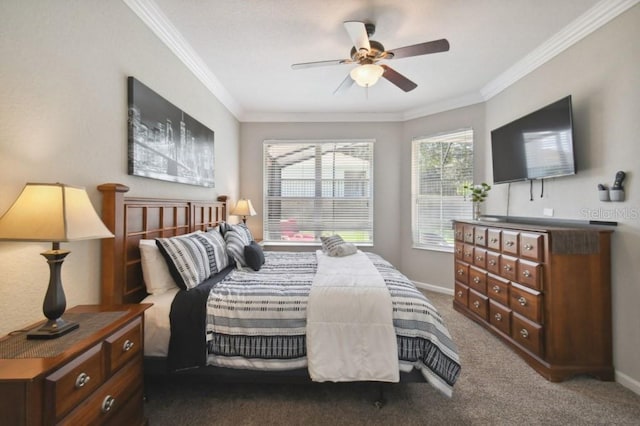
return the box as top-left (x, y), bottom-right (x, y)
top-left (122, 0), bottom-right (243, 118)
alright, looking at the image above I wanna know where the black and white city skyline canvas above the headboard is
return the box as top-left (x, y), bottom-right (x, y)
top-left (128, 77), bottom-right (215, 187)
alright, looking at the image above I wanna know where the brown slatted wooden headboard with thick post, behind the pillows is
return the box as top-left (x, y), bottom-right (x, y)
top-left (98, 183), bottom-right (227, 305)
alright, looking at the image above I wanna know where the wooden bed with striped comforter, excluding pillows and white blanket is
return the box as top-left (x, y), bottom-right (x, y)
top-left (98, 183), bottom-right (460, 396)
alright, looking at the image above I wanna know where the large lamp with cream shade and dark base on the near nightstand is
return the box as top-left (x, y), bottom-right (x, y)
top-left (0, 183), bottom-right (113, 339)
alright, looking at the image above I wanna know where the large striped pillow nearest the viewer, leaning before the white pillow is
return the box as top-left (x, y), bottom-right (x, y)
top-left (156, 231), bottom-right (229, 290)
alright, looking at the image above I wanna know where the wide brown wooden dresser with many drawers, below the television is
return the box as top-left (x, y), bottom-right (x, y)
top-left (453, 221), bottom-right (614, 382)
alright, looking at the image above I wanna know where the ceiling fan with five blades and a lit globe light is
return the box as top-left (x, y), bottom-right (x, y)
top-left (291, 21), bottom-right (449, 94)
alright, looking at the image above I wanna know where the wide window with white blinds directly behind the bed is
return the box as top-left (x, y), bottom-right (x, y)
top-left (264, 140), bottom-right (373, 244)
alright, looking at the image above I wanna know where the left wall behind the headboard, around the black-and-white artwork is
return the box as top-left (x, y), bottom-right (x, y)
top-left (0, 0), bottom-right (239, 334)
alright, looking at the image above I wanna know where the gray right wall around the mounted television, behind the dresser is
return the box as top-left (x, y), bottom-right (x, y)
top-left (484, 6), bottom-right (640, 393)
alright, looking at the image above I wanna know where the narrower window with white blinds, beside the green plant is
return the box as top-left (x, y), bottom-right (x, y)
top-left (411, 129), bottom-right (473, 251)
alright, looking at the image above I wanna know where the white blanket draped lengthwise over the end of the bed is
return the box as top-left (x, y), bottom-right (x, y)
top-left (307, 250), bottom-right (400, 382)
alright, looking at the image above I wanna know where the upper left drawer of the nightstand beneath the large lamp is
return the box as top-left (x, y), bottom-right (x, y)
top-left (44, 344), bottom-right (106, 423)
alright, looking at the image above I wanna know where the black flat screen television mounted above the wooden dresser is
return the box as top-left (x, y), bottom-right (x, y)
top-left (491, 95), bottom-right (576, 184)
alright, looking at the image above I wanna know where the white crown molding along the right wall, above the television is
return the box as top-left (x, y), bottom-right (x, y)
top-left (480, 0), bottom-right (640, 101)
